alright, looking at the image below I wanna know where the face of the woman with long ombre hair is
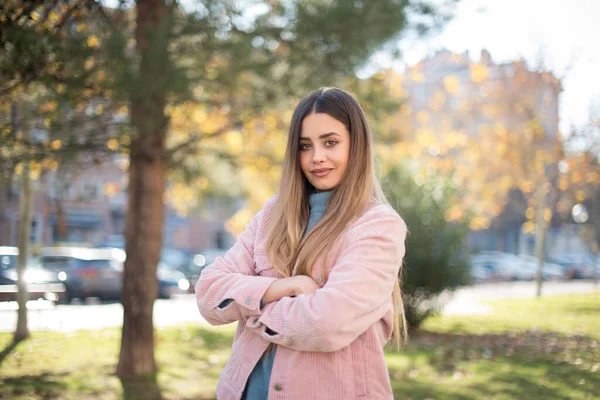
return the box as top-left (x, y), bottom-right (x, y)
top-left (300, 113), bottom-right (350, 192)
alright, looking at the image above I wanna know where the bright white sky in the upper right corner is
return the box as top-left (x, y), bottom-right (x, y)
top-left (392, 0), bottom-right (600, 132)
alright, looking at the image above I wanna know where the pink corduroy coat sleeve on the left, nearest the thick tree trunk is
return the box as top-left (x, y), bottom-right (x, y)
top-left (195, 198), bottom-right (276, 325)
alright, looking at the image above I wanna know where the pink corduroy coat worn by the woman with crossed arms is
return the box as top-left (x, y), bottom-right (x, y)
top-left (196, 198), bottom-right (406, 400)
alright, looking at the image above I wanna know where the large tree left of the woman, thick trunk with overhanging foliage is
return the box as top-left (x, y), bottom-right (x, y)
top-left (0, 0), bottom-right (462, 378)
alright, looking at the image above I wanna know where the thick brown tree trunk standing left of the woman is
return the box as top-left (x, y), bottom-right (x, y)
top-left (117, 0), bottom-right (169, 382)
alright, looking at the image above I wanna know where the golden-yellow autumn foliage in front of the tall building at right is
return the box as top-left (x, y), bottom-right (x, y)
top-left (387, 51), bottom-right (563, 233)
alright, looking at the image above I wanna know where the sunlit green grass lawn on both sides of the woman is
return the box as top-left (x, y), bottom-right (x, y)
top-left (0, 293), bottom-right (600, 400)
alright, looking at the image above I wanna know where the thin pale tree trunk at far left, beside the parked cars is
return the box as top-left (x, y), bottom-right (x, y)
top-left (14, 149), bottom-right (33, 342)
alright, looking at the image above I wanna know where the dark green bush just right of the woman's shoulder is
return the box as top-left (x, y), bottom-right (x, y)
top-left (383, 167), bottom-right (470, 329)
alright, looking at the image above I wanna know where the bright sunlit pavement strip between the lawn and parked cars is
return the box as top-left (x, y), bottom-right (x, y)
top-left (0, 281), bottom-right (600, 332)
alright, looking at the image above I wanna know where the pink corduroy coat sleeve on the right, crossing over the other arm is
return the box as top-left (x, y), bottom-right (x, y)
top-left (246, 211), bottom-right (407, 351)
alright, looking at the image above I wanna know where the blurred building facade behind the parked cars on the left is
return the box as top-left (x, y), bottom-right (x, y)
top-left (0, 157), bottom-right (241, 252)
